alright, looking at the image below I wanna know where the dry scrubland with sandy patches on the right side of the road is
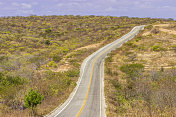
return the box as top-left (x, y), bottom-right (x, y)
top-left (105, 21), bottom-right (176, 117)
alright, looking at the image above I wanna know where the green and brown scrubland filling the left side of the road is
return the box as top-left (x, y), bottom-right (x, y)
top-left (0, 15), bottom-right (170, 117)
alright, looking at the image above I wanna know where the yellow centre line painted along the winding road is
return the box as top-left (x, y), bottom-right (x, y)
top-left (76, 26), bottom-right (142, 117)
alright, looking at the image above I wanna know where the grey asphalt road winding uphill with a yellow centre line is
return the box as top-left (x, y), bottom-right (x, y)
top-left (47, 26), bottom-right (144, 117)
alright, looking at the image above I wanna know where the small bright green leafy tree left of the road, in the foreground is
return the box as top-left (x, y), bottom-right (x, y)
top-left (24, 89), bottom-right (44, 116)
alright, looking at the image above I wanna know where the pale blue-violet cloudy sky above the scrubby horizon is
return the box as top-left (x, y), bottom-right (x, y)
top-left (0, 0), bottom-right (176, 19)
